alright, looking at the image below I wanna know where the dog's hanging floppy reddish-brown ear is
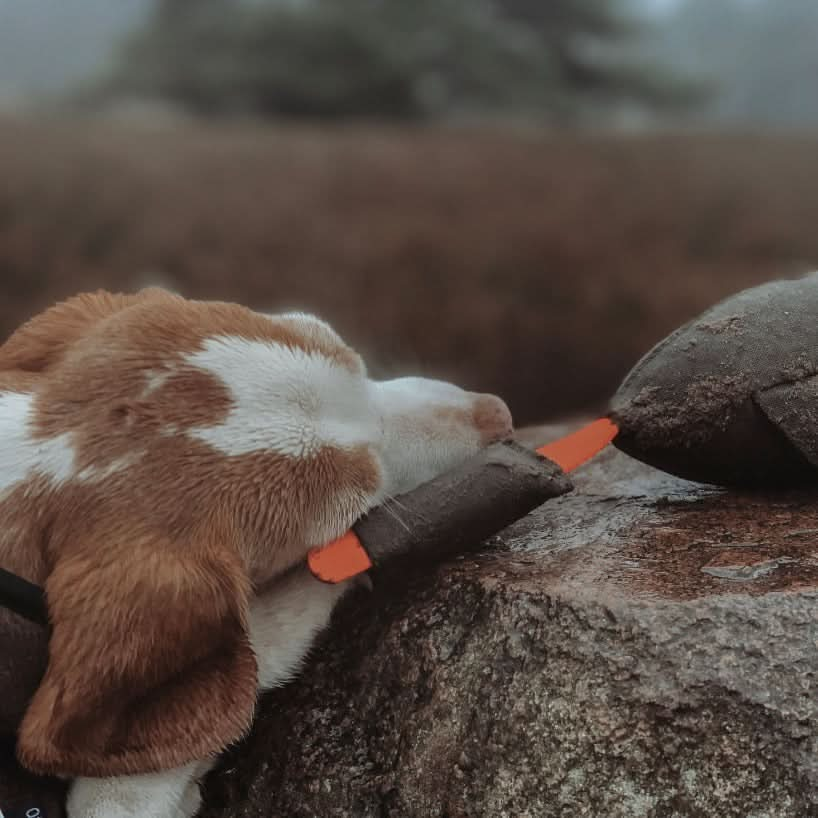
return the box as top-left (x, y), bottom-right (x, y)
top-left (18, 536), bottom-right (257, 777)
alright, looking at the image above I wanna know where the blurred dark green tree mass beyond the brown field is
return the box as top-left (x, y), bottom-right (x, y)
top-left (100, 0), bottom-right (698, 123)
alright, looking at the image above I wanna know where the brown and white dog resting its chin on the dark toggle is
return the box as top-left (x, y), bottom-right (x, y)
top-left (0, 289), bottom-right (511, 818)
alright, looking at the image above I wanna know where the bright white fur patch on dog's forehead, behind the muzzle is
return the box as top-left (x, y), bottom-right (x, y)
top-left (187, 336), bottom-right (380, 457)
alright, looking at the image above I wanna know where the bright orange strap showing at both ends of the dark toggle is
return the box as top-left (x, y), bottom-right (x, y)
top-left (307, 418), bottom-right (619, 583)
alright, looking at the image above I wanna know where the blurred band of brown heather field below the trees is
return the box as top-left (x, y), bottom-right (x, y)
top-left (0, 119), bottom-right (818, 422)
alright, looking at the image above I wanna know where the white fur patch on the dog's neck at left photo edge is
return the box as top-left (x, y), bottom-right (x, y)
top-left (0, 392), bottom-right (76, 498)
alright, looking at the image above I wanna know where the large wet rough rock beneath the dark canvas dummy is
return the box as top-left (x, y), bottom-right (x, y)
top-left (202, 434), bottom-right (818, 818)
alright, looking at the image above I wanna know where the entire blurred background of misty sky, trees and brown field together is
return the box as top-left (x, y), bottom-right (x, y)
top-left (0, 0), bottom-right (818, 423)
